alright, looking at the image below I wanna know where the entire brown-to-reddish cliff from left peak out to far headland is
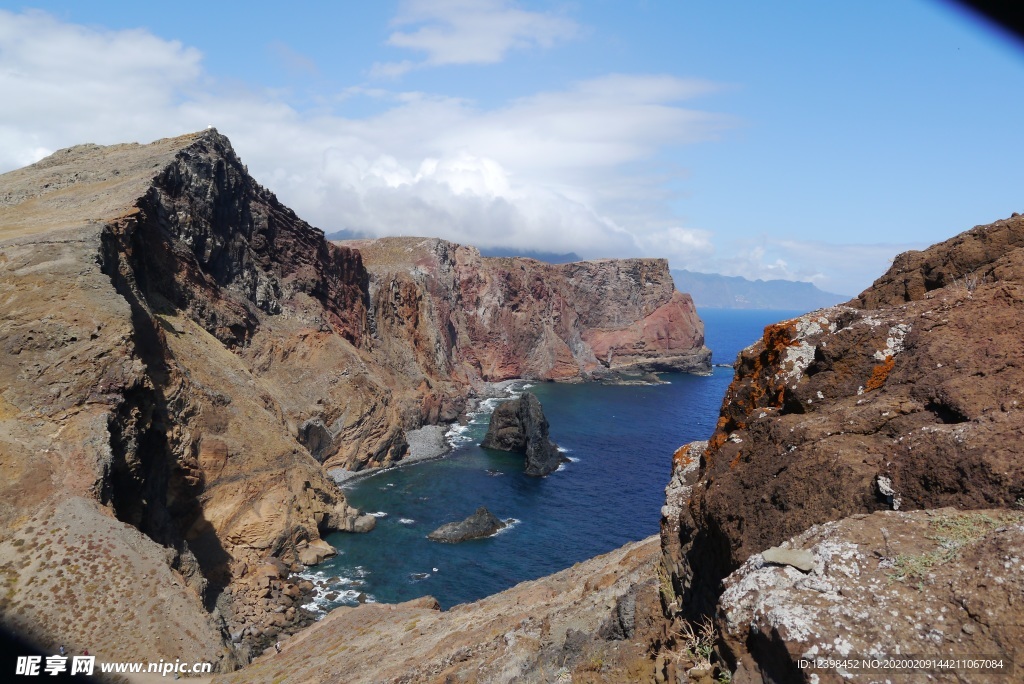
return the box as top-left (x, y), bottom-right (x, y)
top-left (0, 129), bottom-right (708, 670)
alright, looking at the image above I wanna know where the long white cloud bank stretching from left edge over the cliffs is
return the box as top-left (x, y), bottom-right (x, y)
top-left (0, 12), bottom-right (732, 274)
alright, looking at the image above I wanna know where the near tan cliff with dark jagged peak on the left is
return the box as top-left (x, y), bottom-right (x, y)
top-left (0, 130), bottom-right (393, 668)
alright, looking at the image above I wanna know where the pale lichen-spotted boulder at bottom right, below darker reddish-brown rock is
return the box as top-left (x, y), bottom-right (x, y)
top-left (719, 509), bottom-right (1024, 683)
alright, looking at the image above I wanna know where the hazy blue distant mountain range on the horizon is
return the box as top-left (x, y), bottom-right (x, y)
top-left (672, 269), bottom-right (850, 311)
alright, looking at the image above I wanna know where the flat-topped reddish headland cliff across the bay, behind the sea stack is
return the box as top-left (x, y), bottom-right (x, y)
top-left (344, 238), bottom-right (710, 382)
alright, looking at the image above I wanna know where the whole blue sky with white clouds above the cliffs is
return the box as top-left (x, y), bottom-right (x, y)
top-left (0, 0), bottom-right (1024, 295)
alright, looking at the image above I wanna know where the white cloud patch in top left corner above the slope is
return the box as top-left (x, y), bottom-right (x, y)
top-left (0, 10), bottom-right (203, 168)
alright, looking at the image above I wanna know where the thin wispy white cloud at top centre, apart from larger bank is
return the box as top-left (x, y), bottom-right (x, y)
top-left (371, 0), bottom-right (579, 78)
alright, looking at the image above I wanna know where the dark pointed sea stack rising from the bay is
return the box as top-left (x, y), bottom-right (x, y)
top-left (480, 392), bottom-right (567, 477)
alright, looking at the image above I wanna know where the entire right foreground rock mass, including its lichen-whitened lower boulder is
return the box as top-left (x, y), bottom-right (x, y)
top-left (663, 215), bottom-right (1024, 682)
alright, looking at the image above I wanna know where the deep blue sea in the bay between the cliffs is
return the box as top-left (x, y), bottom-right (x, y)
top-left (304, 309), bottom-right (802, 614)
